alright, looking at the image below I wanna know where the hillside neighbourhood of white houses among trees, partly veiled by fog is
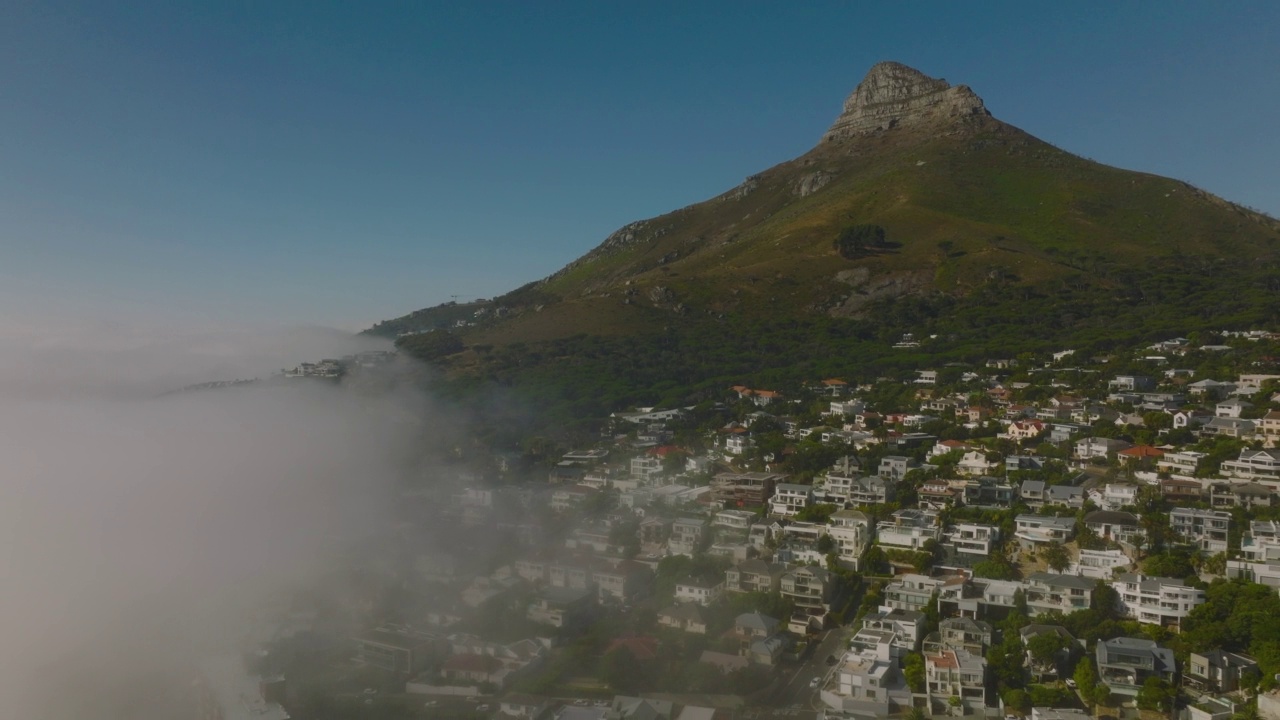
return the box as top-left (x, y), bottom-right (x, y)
top-left (225, 332), bottom-right (1280, 720)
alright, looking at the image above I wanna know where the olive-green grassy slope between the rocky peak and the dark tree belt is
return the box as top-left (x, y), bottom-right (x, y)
top-left (455, 122), bottom-right (1280, 343)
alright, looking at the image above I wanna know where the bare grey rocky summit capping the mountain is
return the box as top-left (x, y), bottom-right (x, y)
top-left (822, 63), bottom-right (991, 142)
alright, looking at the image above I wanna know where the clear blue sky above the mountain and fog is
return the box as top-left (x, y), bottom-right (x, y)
top-left (0, 0), bottom-right (1280, 329)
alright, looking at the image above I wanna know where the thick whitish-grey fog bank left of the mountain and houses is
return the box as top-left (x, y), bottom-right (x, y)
top-left (0, 324), bottom-right (431, 720)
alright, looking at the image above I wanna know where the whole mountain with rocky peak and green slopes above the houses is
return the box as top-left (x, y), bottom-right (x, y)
top-left (367, 63), bottom-right (1280, 422)
